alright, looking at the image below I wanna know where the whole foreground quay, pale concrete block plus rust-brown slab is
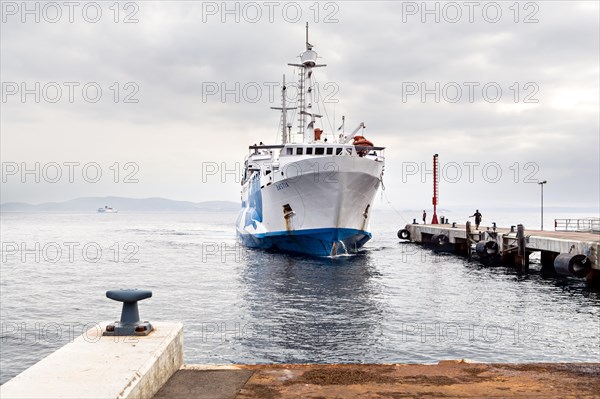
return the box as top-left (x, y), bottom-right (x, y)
top-left (0, 323), bottom-right (600, 399)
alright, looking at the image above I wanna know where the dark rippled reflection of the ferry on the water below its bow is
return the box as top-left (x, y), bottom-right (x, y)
top-left (241, 251), bottom-right (383, 363)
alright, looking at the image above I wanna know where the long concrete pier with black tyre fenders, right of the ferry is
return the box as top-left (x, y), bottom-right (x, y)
top-left (401, 224), bottom-right (600, 280)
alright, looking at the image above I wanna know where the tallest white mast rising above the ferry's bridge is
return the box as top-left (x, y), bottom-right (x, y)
top-left (288, 22), bottom-right (326, 143)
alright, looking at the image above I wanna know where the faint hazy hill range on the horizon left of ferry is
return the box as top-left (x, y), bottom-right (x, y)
top-left (0, 197), bottom-right (240, 212)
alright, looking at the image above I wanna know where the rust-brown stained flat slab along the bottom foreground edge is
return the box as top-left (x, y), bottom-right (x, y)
top-left (155, 361), bottom-right (600, 399)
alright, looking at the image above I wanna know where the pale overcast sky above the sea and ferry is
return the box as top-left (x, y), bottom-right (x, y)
top-left (0, 1), bottom-right (600, 212)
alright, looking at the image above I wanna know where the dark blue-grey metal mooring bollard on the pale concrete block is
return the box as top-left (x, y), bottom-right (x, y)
top-left (102, 289), bottom-right (154, 336)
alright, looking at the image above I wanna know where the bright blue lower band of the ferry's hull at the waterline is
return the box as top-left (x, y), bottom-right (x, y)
top-left (237, 228), bottom-right (371, 256)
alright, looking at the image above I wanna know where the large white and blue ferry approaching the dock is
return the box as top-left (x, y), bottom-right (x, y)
top-left (237, 24), bottom-right (385, 256)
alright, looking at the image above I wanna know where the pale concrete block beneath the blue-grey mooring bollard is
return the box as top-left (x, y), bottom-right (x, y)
top-left (0, 323), bottom-right (183, 399)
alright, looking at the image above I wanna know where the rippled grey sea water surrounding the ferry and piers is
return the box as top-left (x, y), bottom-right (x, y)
top-left (0, 211), bottom-right (600, 383)
